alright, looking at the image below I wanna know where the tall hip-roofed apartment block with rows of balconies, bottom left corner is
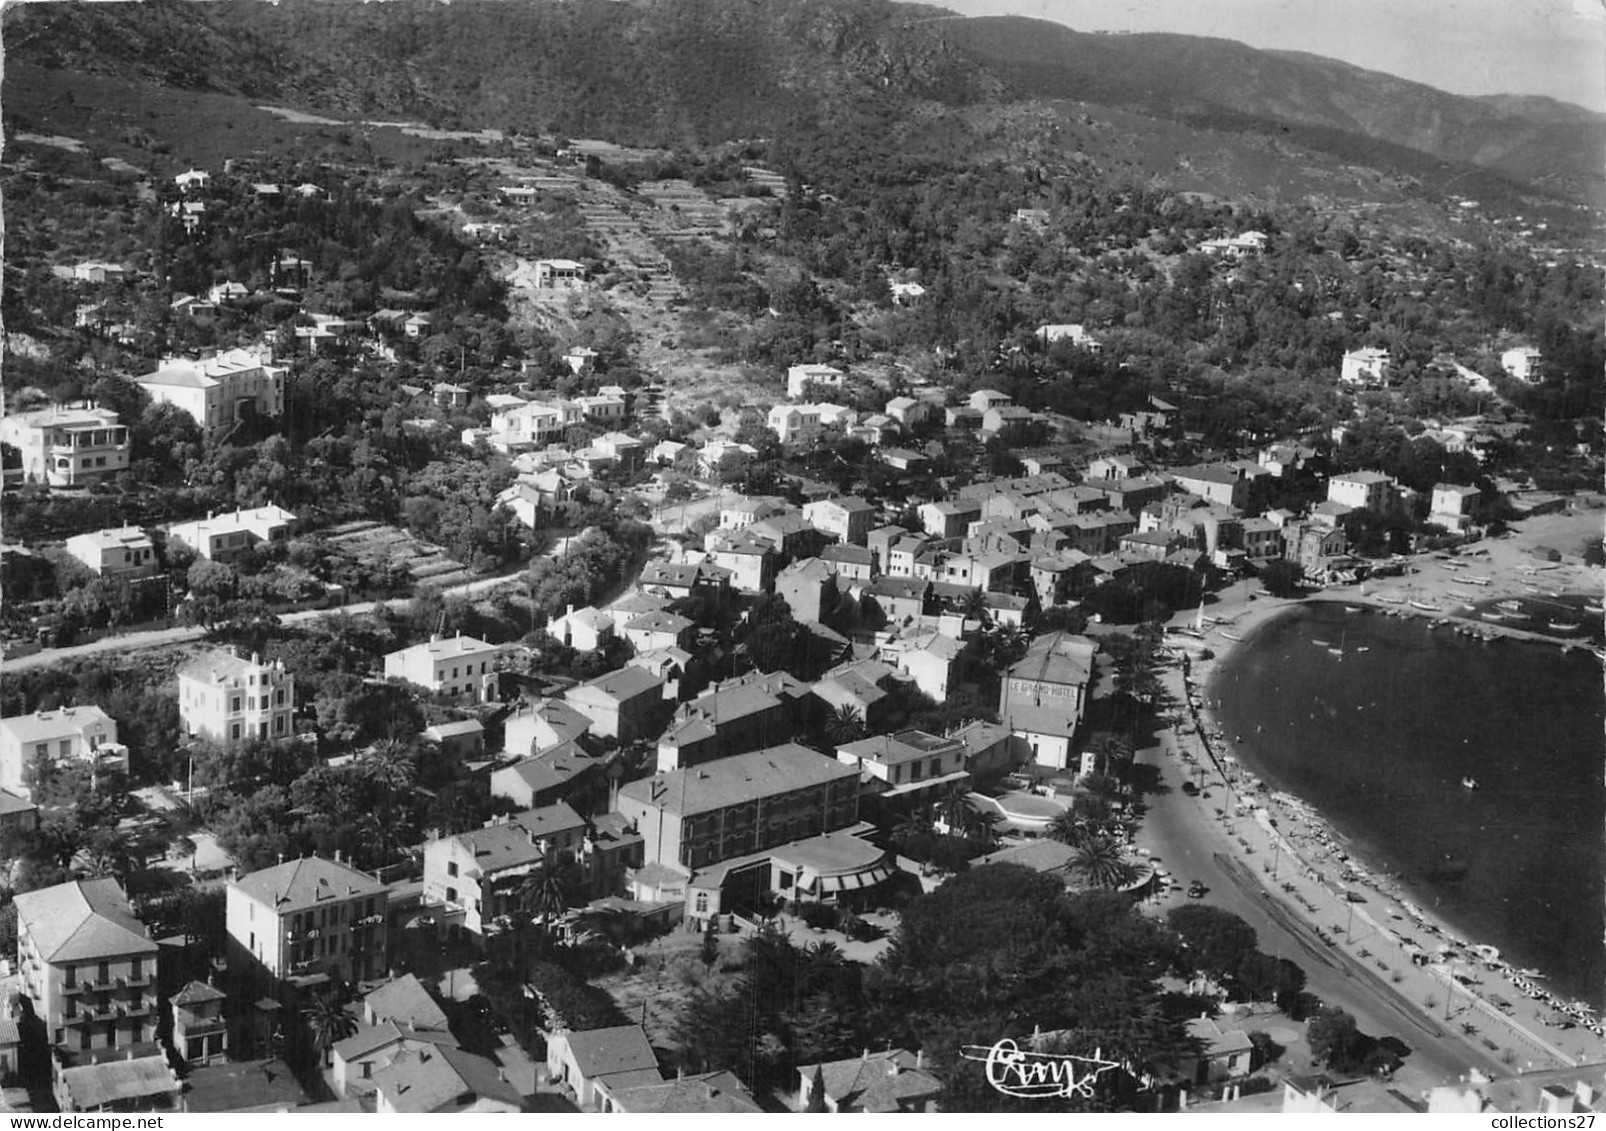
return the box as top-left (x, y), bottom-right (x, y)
top-left (14, 877), bottom-right (157, 1066)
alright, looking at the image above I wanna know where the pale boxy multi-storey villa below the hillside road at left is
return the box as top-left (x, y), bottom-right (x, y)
top-left (178, 652), bottom-right (296, 745)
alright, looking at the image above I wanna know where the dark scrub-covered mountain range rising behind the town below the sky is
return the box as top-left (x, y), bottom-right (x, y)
top-left (5, 0), bottom-right (1606, 210)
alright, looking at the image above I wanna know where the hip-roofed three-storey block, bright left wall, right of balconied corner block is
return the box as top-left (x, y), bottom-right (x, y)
top-left (225, 856), bottom-right (390, 1008)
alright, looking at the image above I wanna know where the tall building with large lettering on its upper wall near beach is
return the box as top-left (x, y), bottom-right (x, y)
top-left (999, 631), bottom-right (1099, 770)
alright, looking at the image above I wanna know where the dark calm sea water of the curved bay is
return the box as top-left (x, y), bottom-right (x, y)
top-left (1206, 604), bottom-right (1606, 1006)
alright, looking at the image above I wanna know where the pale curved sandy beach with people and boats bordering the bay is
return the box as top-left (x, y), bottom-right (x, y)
top-left (1161, 512), bottom-right (1606, 1075)
